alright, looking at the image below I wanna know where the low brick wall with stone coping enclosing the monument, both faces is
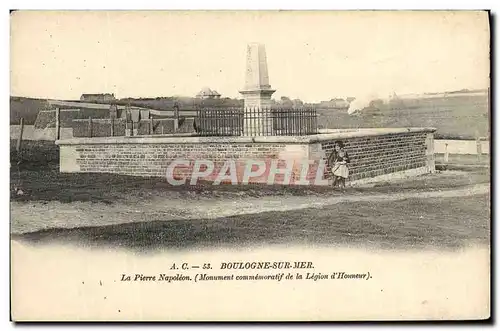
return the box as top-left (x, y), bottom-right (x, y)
top-left (57, 129), bottom-right (434, 185)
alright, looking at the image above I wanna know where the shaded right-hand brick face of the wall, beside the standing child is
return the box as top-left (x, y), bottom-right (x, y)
top-left (321, 132), bottom-right (427, 181)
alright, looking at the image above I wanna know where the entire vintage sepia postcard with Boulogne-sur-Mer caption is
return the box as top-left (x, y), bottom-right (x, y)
top-left (10, 10), bottom-right (491, 322)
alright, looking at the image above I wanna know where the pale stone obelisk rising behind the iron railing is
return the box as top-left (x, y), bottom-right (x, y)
top-left (240, 43), bottom-right (276, 136)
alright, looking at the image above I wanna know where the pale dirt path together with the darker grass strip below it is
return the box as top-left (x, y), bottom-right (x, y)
top-left (12, 185), bottom-right (489, 250)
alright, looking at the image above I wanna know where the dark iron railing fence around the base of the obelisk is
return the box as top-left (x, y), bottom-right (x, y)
top-left (196, 107), bottom-right (318, 136)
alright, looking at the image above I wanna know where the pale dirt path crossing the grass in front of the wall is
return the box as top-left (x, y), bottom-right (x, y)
top-left (11, 178), bottom-right (489, 233)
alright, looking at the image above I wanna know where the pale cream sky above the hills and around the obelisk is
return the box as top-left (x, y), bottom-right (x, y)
top-left (10, 11), bottom-right (489, 102)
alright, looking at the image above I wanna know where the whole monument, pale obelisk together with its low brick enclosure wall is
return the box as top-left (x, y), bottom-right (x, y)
top-left (57, 44), bottom-right (435, 185)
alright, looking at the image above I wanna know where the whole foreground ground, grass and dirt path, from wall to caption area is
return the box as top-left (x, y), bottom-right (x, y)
top-left (11, 160), bottom-right (490, 251)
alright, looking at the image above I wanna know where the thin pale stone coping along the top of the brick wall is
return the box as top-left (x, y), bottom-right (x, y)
top-left (55, 128), bottom-right (436, 145)
